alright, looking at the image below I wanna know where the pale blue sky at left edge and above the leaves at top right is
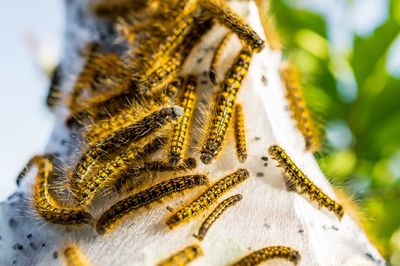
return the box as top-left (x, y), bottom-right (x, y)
top-left (0, 0), bottom-right (392, 201)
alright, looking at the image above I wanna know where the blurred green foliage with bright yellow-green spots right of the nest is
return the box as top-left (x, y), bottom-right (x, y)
top-left (271, 0), bottom-right (400, 265)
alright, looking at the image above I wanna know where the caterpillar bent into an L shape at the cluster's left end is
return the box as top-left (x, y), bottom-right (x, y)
top-left (33, 157), bottom-right (92, 225)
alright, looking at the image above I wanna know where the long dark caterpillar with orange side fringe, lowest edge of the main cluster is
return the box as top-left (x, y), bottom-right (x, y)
top-left (96, 175), bottom-right (207, 235)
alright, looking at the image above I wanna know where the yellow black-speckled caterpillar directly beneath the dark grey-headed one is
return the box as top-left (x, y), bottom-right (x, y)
top-left (72, 136), bottom-right (167, 206)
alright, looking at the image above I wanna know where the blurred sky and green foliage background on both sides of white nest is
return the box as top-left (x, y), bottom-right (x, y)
top-left (0, 0), bottom-right (400, 265)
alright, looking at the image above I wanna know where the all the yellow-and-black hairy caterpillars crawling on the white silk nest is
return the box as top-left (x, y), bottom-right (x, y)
top-left (17, 0), bottom-right (343, 265)
